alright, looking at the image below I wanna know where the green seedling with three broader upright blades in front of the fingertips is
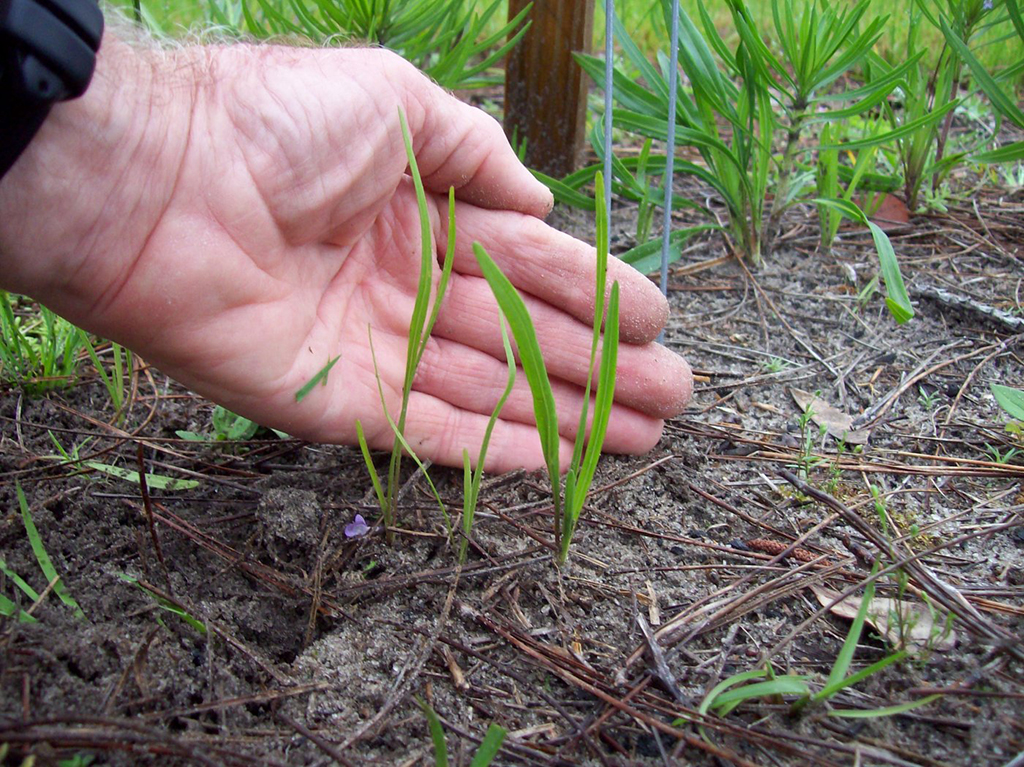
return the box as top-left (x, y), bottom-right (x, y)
top-left (473, 173), bottom-right (618, 562)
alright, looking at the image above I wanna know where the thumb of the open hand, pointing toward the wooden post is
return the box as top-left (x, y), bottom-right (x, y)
top-left (393, 66), bottom-right (554, 218)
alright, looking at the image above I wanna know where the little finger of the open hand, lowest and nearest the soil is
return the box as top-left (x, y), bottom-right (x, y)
top-left (367, 391), bottom-right (572, 473)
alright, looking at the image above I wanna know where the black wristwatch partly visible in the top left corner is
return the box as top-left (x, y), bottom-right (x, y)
top-left (0, 0), bottom-right (103, 178)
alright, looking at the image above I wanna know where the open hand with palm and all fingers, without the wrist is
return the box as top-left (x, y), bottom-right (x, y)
top-left (86, 49), bottom-right (689, 470)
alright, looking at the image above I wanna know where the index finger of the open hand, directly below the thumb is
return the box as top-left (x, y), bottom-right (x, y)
top-left (441, 198), bottom-right (669, 343)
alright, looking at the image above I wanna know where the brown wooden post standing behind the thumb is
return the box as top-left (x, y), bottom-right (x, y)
top-left (505, 0), bottom-right (594, 178)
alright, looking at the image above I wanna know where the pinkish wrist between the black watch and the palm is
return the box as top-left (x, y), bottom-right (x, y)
top-left (0, 33), bottom-right (195, 319)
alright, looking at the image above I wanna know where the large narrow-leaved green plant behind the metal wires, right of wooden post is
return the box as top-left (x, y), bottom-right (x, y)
top-left (579, 0), bottom-right (917, 262)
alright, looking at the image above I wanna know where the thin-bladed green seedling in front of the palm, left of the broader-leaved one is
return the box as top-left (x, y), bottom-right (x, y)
top-left (355, 112), bottom-right (456, 543)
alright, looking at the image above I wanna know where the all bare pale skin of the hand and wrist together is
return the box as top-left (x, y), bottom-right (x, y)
top-left (0, 34), bottom-right (692, 471)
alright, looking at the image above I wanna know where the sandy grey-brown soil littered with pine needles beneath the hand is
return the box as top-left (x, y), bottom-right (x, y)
top-left (0, 164), bottom-right (1024, 765)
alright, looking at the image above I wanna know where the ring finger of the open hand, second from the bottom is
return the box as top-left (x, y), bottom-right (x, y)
top-left (414, 339), bottom-right (664, 454)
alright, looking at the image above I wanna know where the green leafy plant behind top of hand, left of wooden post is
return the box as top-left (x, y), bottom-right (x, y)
top-left (209, 0), bottom-right (529, 89)
